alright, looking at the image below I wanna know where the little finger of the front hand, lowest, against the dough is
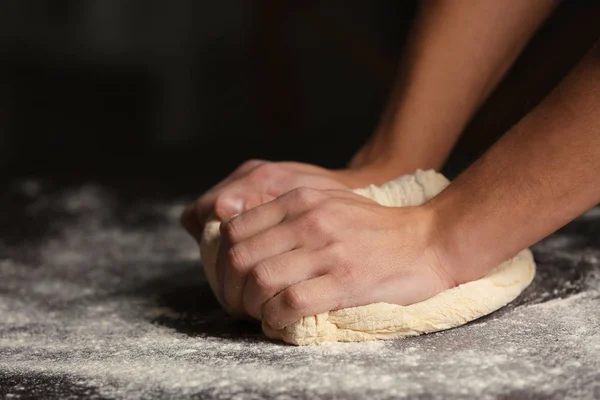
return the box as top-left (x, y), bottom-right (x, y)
top-left (263, 274), bottom-right (343, 330)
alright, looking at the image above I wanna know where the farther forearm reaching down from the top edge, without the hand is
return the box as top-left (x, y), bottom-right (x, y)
top-left (350, 0), bottom-right (556, 181)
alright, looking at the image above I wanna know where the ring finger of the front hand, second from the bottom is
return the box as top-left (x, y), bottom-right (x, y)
top-left (242, 250), bottom-right (325, 320)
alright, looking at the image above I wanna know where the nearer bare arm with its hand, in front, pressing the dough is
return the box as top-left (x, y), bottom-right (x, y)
top-left (217, 45), bottom-right (600, 329)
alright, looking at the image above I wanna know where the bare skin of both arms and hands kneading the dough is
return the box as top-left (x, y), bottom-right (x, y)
top-left (182, 1), bottom-right (600, 329)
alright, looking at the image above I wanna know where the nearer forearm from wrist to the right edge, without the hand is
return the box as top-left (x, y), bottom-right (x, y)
top-left (427, 44), bottom-right (600, 282)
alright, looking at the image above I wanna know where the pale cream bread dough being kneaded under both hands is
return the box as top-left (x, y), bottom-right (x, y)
top-left (201, 170), bottom-right (535, 345)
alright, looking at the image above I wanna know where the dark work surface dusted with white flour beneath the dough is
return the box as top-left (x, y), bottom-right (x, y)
top-left (0, 181), bottom-right (600, 399)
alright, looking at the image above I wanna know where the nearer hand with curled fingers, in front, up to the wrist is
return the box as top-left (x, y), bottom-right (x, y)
top-left (217, 188), bottom-right (454, 329)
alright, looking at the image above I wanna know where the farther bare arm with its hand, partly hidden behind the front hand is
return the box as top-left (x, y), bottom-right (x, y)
top-left (182, 0), bottom-right (557, 233)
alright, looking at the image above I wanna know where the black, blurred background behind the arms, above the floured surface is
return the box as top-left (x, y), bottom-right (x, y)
top-left (0, 0), bottom-right (600, 192)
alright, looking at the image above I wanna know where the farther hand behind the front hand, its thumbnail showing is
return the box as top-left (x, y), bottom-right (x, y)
top-left (181, 160), bottom-right (371, 240)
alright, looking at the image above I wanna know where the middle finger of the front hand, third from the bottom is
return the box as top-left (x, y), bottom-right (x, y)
top-left (223, 224), bottom-right (298, 312)
